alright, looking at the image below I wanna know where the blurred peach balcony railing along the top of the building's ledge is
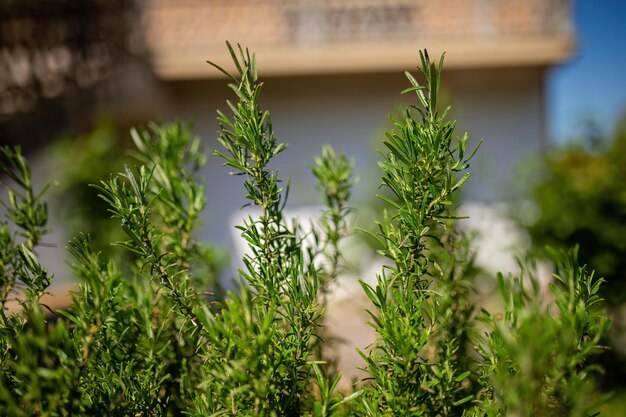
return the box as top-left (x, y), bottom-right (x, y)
top-left (145, 0), bottom-right (572, 46)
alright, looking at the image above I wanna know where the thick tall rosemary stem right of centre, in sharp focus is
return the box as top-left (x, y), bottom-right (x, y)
top-left (362, 53), bottom-right (473, 416)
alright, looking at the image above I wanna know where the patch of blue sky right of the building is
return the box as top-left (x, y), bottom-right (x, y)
top-left (547, 0), bottom-right (626, 143)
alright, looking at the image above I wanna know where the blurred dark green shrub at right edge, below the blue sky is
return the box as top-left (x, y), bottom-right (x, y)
top-left (529, 125), bottom-right (626, 304)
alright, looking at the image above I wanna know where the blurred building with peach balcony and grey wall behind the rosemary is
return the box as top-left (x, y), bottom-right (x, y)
top-left (134, 0), bottom-right (574, 240)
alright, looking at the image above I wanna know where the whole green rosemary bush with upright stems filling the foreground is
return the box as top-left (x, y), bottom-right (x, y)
top-left (0, 45), bottom-right (608, 417)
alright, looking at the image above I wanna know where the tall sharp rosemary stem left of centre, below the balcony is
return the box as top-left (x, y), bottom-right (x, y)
top-left (190, 45), bottom-right (321, 416)
